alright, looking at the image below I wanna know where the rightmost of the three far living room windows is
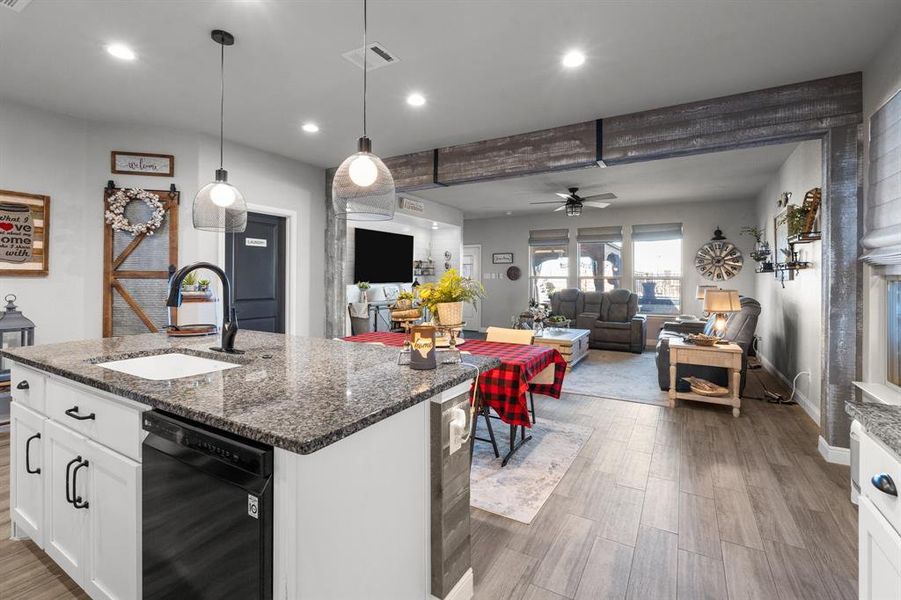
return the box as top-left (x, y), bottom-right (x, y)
top-left (632, 223), bottom-right (682, 315)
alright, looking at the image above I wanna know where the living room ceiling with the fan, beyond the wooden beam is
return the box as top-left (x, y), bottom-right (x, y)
top-left (412, 144), bottom-right (798, 219)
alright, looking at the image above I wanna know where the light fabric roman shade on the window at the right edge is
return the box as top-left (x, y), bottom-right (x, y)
top-left (861, 92), bottom-right (901, 273)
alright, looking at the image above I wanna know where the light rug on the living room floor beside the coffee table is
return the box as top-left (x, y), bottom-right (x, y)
top-left (563, 350), bottom-right (667, 405)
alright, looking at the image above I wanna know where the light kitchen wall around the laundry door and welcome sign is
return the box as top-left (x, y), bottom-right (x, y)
top-left (0, 101), bottom-right (325, 343)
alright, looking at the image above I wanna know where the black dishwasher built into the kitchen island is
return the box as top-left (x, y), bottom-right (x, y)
top-left (142, 411), bottom-right (273, 600)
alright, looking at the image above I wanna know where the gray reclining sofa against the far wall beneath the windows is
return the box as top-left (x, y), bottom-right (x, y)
top-left (551, 288), bottom-right (648, 354)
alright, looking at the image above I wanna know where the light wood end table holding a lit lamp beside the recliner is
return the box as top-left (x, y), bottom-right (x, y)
top-left (669, 338), bottom-right (742, 417)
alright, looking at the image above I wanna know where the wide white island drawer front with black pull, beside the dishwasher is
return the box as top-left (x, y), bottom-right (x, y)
top-left (46, 378), bottom-right (149, 461)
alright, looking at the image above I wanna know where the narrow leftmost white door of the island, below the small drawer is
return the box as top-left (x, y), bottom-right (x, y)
top-left (9, 402), bottom-right (46, 548)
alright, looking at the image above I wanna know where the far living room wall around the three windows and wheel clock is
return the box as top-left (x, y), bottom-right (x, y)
top-left (463, 196), bottom-right (757, 328)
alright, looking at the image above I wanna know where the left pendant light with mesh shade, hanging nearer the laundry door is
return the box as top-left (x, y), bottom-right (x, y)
top-left (193, 29), bottom-right (247, 233)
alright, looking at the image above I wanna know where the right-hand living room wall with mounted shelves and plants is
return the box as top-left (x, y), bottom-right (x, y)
top-left (756, 140), bottom-right (823, 423)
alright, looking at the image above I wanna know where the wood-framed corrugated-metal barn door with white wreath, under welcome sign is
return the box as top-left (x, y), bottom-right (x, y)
top-left (103, 186), bottom-right (179, 337)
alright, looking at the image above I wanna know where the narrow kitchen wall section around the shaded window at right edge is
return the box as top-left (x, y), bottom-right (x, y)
top-left (862, 22), bottom-right (901, 383)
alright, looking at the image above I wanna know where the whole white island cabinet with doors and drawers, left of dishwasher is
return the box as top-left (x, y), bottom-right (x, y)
top-left (10, 365), bottom-right (148, 600)
